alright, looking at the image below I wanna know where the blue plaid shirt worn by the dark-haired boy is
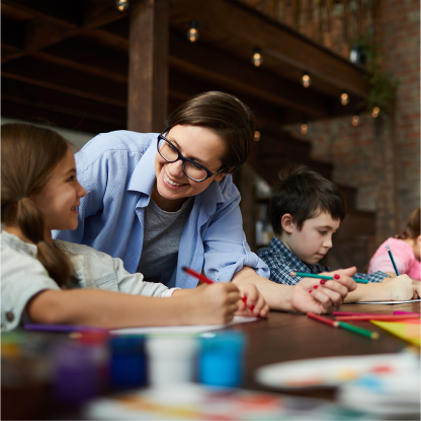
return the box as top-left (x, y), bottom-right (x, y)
top-left (257, 236), bottom-right (389, 285)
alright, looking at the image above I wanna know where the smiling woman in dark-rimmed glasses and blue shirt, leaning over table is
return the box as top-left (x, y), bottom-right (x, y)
top-left (50, 91), bottom-right (352, 313)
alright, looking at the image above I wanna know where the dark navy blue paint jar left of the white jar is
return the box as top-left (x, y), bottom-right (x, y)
top-left (110, 336), bottom-right (147, 389)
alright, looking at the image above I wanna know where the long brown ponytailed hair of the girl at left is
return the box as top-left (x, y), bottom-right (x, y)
top-left (0, 124), bottom-right (70, 286)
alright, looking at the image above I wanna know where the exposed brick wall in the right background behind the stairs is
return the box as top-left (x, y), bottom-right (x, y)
top-left (290, 0), bottom-right (421, 235)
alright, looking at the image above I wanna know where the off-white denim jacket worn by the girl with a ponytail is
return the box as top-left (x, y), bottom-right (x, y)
top-left (0, 231), bottom-right (178, 332)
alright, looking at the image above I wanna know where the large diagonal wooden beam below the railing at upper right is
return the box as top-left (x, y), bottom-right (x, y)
top-left (171, 0), bottom-right (369, 98)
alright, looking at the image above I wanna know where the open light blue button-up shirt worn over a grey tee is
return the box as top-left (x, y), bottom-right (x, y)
top-left (53, 131), bottom-right (269, 288)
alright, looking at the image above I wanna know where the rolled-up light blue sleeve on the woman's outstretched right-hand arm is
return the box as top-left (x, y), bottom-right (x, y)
top-left (203, 177), bottom-right (270, 282)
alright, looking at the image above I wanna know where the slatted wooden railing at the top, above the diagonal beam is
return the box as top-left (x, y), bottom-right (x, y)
top-left (238, 0), bottom-right (379, 58)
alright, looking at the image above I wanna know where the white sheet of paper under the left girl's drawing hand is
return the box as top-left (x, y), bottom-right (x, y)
top-left (110, 316), bottom-right (260, 335)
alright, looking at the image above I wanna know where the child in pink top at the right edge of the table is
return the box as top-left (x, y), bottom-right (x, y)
top-left (368, 208), bottom-right (421, 280)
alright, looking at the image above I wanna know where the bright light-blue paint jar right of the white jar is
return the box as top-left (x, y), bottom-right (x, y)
top-left (199, 331), bottom-right (246, 387)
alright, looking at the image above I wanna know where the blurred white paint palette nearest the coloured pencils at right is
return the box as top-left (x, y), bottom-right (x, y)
top-left (255, 354), bottom-right (417, 389)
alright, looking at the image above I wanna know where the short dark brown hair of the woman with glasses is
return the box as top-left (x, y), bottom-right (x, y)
top-left (165, 91), bottom-right (256, 169)
